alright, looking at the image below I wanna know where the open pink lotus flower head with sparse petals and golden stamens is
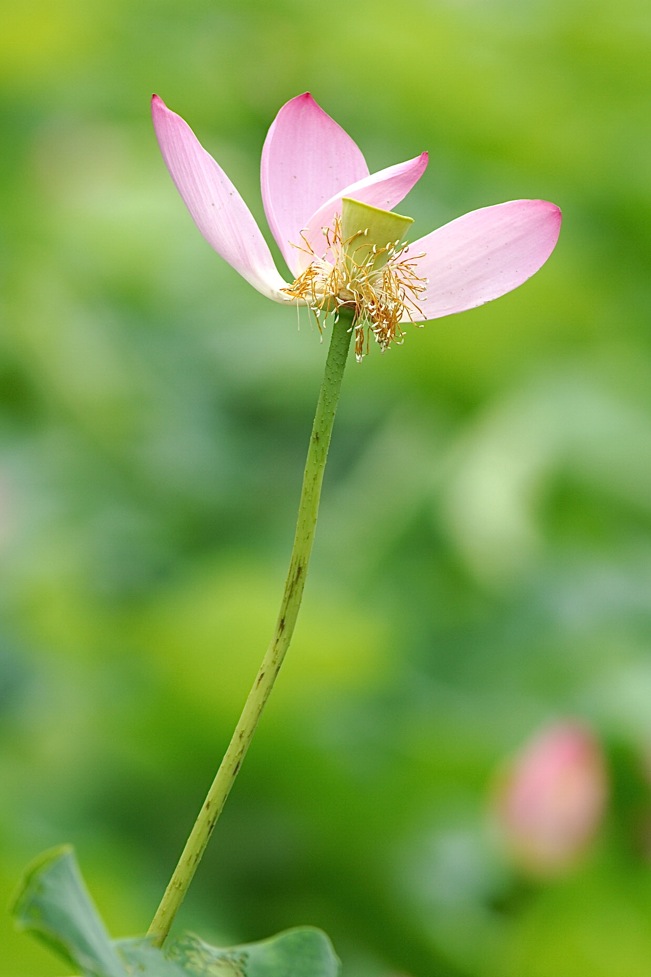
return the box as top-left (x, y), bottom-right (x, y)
top-left (152, 93), bottom-right (561, 359)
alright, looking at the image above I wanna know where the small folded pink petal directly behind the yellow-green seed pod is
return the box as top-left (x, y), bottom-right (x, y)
top-left (298, 153), bottom-right (429, 274)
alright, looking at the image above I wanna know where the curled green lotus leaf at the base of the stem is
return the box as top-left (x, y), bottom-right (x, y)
top-left (14, 847), bottom-right (339, 977)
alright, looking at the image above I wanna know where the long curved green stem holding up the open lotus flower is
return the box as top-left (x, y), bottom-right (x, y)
top-left (148, 315), bottom-right (353, 946)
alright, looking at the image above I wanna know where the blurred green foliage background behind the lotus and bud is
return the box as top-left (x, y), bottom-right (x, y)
top-left (0, 0), bottom-right (651, 977)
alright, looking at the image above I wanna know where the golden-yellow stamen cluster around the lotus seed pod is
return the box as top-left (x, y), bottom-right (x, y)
top-left (284, 215), bottom-right (426, 361)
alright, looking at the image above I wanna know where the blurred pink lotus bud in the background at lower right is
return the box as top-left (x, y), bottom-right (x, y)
top-left (496, 721), bottom-right (608, 875)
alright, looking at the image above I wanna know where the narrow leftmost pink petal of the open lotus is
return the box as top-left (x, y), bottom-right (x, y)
top-left (152, 95), bottom-right (288, 302)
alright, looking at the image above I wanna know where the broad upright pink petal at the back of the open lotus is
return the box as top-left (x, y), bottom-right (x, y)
top-left (260, 92), bottom-right (368, 268)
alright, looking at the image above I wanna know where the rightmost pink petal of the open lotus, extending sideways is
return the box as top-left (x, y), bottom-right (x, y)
top-left (407, 200), bottom-right (561, 321)
